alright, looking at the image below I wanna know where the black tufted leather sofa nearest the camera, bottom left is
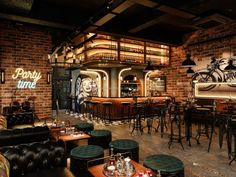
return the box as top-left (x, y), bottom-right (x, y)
top-left (0, 140), bottom-right (69, 177)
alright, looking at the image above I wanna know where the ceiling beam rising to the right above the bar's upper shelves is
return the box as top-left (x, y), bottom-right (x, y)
top-left (129, 14), bottom-right (170, 33)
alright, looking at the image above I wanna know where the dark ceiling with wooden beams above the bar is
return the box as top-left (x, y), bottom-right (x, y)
top-left (0, 0), bottom-right (236, 48)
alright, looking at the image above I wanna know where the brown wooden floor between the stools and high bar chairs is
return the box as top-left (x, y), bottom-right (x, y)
top-left (46, 112), bottom-right (236, 177)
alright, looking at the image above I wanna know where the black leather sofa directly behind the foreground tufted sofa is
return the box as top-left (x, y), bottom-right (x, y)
top-left (0, 126), bottom-right (49, 147)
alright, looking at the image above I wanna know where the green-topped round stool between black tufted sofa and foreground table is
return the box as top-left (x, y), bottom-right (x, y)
top-left (70, 145), bottom-right (104, 177)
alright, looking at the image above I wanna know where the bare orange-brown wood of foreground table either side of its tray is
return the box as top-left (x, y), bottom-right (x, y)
top-left (88, 160), bottom-right (148, 177)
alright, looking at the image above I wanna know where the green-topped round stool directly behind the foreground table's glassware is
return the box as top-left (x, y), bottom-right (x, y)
top-left (109, 139), bottom-right (139, 162)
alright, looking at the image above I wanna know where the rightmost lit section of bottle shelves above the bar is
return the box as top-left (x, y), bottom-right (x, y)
top-left (146, 42), bottom-right (170, 65)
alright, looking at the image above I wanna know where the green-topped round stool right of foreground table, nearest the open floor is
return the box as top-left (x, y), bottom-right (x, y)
top-left (143, 154), bottom-right (184, 177)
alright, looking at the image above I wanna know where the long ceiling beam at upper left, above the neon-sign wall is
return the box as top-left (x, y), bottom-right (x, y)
top-left (0, 13), bottom-right (74, 30)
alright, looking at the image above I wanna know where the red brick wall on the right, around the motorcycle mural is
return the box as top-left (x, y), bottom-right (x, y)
top-left (154, 23), bottom-right (236, 100)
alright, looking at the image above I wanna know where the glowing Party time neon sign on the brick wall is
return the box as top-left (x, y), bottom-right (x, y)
top-left (11, 68), bottom-right (42, 89)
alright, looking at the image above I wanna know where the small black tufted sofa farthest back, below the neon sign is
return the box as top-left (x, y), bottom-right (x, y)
top-left (6, 112), bottom-right (35, 128)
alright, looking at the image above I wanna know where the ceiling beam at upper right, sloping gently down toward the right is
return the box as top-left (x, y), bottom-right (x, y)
top-left (157, 5), bottom-right (196, 19)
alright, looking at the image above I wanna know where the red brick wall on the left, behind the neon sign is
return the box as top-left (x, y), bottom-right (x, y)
top-left (0, 22), bottom-right (51, 118)
